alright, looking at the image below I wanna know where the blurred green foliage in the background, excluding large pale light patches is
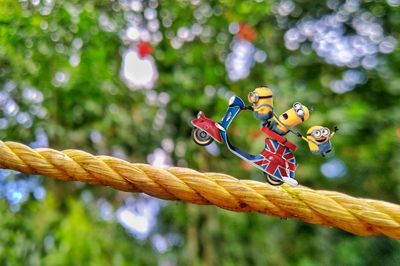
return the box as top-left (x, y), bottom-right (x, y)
top-left (0, 0), bottom-right (400, 265)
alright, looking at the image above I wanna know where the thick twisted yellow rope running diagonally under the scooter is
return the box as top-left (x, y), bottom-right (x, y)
top-left (0, 141), bottom-right (400, 239)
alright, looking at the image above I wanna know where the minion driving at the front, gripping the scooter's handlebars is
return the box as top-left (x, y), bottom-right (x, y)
top-left (247, 87), bottom-right (273, 124)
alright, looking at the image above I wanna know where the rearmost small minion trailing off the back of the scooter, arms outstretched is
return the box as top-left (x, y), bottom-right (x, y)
top-left (303, 126), bottom-right (338, 157)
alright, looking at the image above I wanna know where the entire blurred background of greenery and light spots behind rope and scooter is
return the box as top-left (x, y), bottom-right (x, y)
top-left (0, 0), bottom-right (400, 266)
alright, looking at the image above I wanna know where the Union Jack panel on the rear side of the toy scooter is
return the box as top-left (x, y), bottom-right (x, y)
top-left (251, 138), bottom-right (296, 179)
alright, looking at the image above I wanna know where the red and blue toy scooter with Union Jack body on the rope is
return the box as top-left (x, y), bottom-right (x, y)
top-left (191, 96), bottom-right (298, 186)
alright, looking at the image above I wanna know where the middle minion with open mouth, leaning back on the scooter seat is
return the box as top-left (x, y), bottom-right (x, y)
top-left (269, 102), bottom-right (310, 136)
